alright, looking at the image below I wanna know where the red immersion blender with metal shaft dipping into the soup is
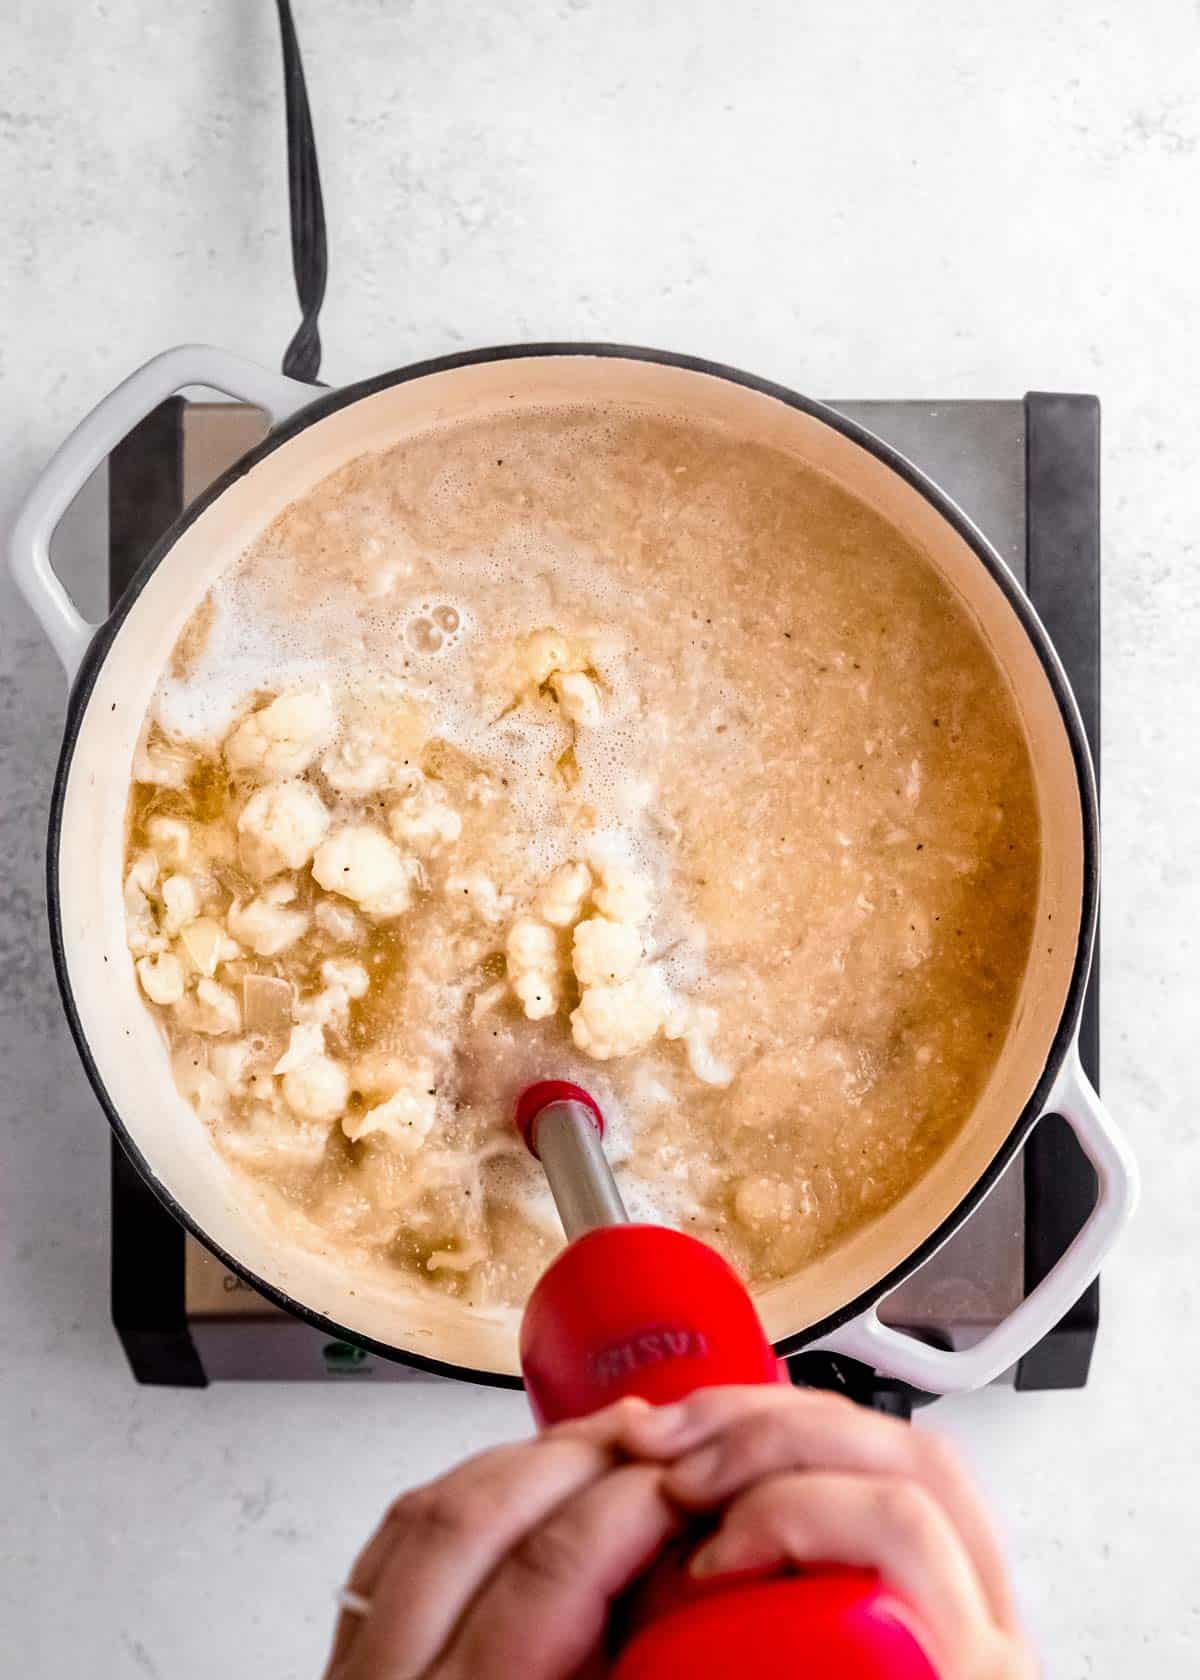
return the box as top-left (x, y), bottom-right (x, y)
top-left (516, 1080), bottom-right (938, 1680)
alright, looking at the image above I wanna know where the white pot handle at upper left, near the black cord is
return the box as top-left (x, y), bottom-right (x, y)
top-left (8, 344), bottom-right (319, 682)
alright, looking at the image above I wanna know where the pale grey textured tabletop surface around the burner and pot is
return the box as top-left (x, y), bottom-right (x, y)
top-left (0, 0), bottom-right (1200, 1680)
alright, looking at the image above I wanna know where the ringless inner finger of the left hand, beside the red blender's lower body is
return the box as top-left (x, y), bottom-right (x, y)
top-left (437, 1465), bottom-right (682, 1680)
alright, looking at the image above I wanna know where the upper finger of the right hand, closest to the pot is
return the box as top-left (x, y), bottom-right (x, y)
top-left (620, 1386), bottom-right (1017, 1628)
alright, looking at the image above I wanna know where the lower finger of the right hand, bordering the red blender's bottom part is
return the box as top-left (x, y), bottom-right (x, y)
top-left (691, 1470), bottom-right (1002, 1673)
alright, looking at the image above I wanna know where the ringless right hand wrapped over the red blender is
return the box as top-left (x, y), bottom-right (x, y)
top-left (617, 1388), bottom-right (1037, 1680)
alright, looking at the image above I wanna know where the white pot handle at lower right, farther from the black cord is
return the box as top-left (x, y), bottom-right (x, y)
top-left (803, 1043), bottom-right (1138, 1394)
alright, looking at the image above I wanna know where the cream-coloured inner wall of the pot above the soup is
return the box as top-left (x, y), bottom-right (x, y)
top-left (59, 356), bottom-right (1082, 1373)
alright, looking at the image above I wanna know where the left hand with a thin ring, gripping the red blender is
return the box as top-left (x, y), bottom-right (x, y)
top-left (326, 1399), bottom-right (682, 1680)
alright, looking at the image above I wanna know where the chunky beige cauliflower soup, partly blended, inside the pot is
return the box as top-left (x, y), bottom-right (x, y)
top-left (126, 407), bottom-right (1040, 1307)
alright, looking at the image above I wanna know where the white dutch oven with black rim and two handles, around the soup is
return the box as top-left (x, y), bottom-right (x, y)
top-left (10, 344), bottom-right (1136, 1393)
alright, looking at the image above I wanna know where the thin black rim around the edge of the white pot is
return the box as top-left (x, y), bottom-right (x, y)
top-left (45, 343), bottom-right (1099, 1388)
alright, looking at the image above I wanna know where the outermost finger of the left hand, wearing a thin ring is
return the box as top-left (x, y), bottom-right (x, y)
top-left (331, 1436), bottom-right (612, 1680)
